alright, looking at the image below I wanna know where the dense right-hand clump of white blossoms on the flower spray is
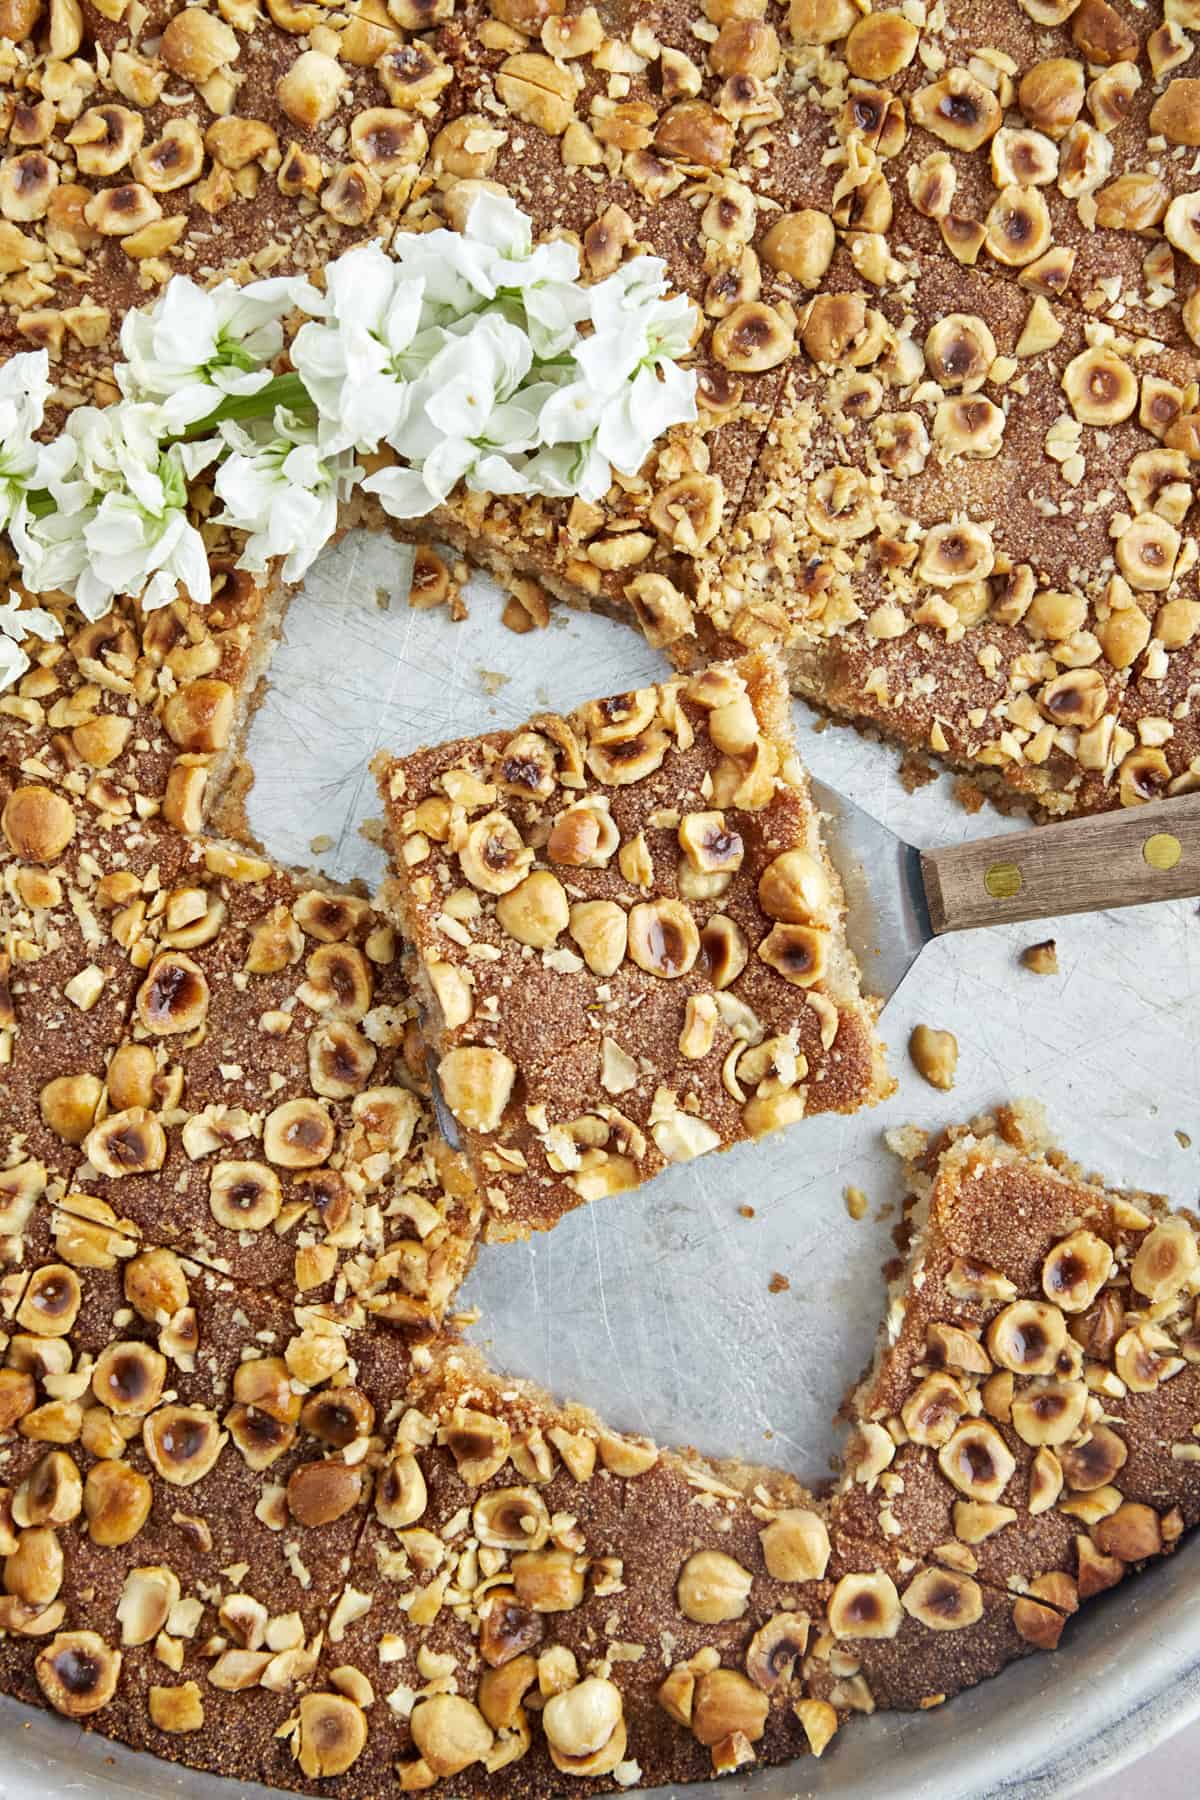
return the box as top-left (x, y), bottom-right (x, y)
top-left (291, 193), bottom-right (696, 518)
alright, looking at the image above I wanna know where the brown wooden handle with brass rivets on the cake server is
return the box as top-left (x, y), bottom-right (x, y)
top-left (921, 794), bottom-right (1200, 934)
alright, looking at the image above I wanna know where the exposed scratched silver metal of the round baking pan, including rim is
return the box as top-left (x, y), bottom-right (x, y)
top-left (0, 535), bottom-right (1200, 1800)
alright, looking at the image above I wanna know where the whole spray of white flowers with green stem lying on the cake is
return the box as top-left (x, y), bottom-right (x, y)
top-left (0, 193), bottom-right (696, 688)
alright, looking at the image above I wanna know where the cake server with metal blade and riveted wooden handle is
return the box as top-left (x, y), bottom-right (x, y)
top-left (811, 779), bottom-right (1200, 1001)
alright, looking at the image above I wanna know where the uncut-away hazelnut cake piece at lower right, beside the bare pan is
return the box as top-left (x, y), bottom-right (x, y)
top-left (837, 1103), bottom-right (1200, 1631)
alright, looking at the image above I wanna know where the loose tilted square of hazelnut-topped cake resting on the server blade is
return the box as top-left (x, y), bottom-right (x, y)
top-left (376, 652), bottom-right (891, 1240)
